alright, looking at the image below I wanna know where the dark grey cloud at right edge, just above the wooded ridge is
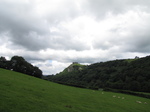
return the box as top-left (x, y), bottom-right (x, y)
top-left (122, 17), bottom-right (150, 53)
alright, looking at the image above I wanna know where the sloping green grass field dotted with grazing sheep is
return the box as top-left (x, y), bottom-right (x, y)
top-left (0, 69), bottom-right (150, 112)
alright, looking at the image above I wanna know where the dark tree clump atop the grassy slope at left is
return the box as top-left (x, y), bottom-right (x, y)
top-left (0, 56), bottom-right (43, 78)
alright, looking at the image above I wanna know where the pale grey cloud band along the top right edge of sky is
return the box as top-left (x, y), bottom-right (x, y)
top-left (84, 0), bottom-right (150, 18)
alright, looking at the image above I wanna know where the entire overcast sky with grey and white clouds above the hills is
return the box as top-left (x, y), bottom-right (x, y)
top-left (0, 0), bottom-right (150, 75)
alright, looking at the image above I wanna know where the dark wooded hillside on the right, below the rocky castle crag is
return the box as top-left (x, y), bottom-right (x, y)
top-left (47, 56), bottom-right (150, 92)
